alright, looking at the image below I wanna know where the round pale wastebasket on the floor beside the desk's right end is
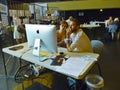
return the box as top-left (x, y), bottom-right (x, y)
top-left (85, 74), bottom-right (104, 90)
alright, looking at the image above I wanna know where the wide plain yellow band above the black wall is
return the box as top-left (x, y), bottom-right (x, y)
top-left (48, 0), bottom-right (120, 10)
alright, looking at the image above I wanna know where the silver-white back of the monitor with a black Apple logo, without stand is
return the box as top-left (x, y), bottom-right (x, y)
top-left (25, 24), bottom-right (57, 53)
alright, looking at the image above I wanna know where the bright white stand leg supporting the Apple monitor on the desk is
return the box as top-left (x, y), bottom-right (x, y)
top-left (32, 39), bottom-right (40, 56)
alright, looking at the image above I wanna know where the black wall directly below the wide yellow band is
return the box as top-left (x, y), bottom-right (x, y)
top-left (60, 8), bottom-right (120, 23)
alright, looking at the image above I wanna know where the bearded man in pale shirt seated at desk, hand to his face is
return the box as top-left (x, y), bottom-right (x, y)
top-left (64, 19), bottom-right (93, 52)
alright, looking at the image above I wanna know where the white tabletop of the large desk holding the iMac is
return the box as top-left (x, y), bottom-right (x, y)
top-left (2, 43), bottom-right (99, 79)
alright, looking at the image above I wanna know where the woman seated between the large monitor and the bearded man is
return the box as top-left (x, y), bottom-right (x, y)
top-left (57, 20), bottom-right (68, 47)
